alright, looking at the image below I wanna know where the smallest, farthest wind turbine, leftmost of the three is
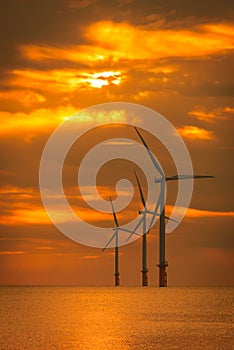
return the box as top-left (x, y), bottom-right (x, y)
top-left (102, 197), bottom-right (140, 286)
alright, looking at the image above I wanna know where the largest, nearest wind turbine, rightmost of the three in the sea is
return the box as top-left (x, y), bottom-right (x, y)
top-left (134, 127), bottom-right (214, 287)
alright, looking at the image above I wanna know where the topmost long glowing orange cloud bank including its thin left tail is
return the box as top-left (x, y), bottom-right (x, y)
top-left (19, 21), bottom-right (234, 64)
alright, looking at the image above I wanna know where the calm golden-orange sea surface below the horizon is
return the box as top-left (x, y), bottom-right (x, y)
top-left (0, 286), bottom-right (234, 350)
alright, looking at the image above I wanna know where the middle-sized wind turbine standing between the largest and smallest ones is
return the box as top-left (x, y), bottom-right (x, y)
top-left (127, 171), bottom-right (175, 286)
